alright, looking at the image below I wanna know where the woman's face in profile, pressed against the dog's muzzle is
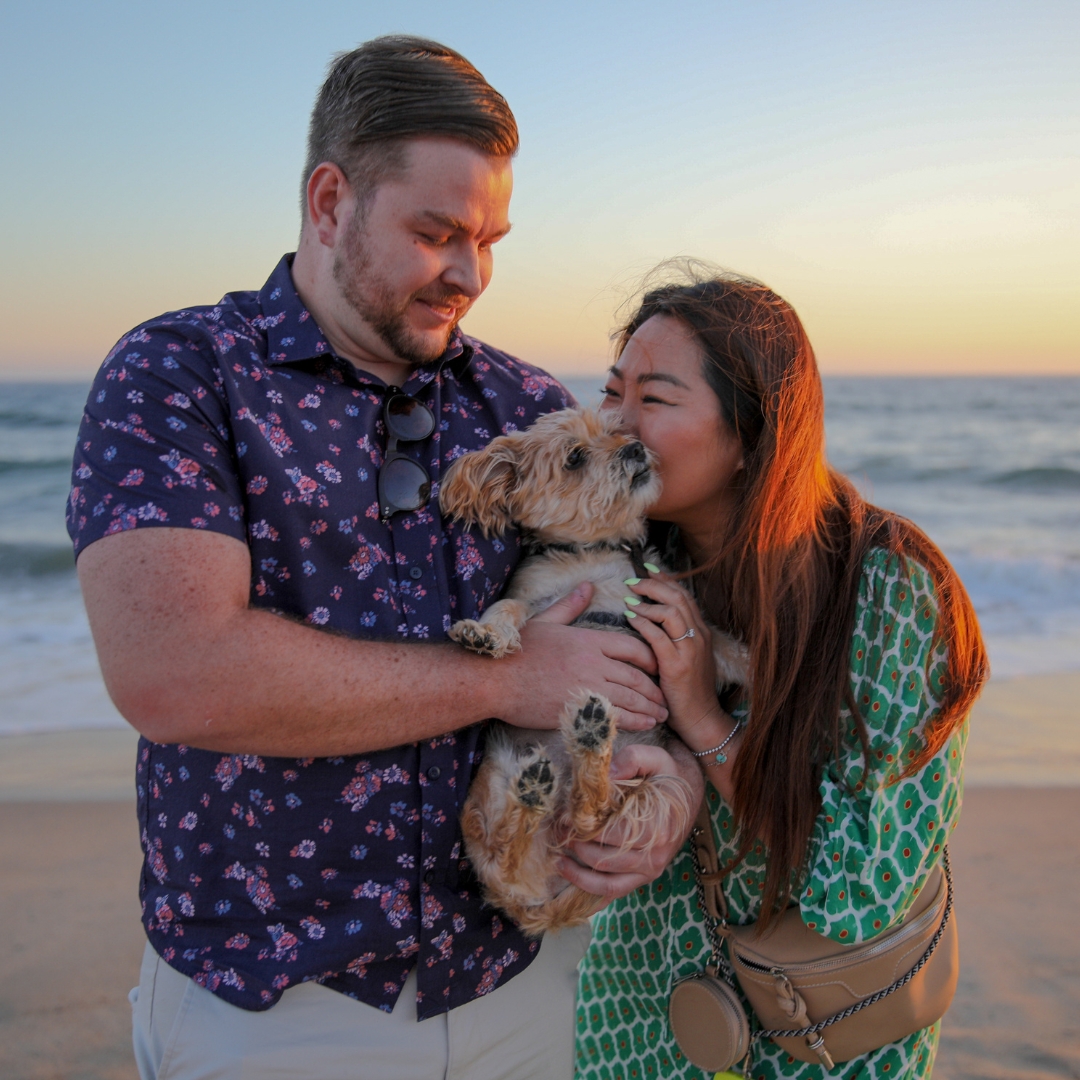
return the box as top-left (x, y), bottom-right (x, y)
top-left (600, 315), bottom-right (743, 543)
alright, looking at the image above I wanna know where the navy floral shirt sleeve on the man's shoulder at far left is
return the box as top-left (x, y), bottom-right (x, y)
top-left (67, 320), bottom-right (245, 555)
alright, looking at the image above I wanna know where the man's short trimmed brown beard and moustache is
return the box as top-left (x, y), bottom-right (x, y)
top-left (334, 214), bottom-right (465, 364)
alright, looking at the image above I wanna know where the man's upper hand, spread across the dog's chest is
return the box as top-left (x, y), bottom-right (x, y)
top-left (489, 582), bottom-right (667, 731)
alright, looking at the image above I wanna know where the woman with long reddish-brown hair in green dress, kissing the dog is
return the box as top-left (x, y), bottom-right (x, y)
top-left (578, 274), bottom-right (987, 1080)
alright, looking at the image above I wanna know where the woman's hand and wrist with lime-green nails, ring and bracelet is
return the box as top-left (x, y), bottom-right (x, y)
top-left (625, 567), bottom-right (742, 802)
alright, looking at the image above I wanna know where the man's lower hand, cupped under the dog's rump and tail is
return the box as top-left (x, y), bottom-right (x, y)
top-left (557, 742), bottom-right (705, 903)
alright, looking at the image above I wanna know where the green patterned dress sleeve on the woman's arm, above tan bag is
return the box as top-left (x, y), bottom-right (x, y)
top-left (799, 551), bottom-right (968, 944)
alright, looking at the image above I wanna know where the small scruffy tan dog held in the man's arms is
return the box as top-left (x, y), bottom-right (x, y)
top-left (440, 409), bottom-right (746, 935)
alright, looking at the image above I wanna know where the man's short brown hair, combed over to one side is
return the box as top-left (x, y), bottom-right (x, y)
top-left (300, 35), bottom-right (517, 217)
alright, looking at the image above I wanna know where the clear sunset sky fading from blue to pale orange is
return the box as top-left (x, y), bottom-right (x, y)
top-left (0, 0), bottom-right (1080, 379)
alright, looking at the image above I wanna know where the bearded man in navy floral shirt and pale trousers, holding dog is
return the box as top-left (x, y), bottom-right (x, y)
top-left (69, 38), bottom-right (701, 1080)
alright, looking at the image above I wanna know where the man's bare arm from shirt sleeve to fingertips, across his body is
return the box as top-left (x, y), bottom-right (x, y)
top-left (78, 528), bottom-right (666, 757)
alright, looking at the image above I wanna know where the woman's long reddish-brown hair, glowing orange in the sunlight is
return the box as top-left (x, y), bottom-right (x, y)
top-left (616, 265), bottom-right (988, 929)
